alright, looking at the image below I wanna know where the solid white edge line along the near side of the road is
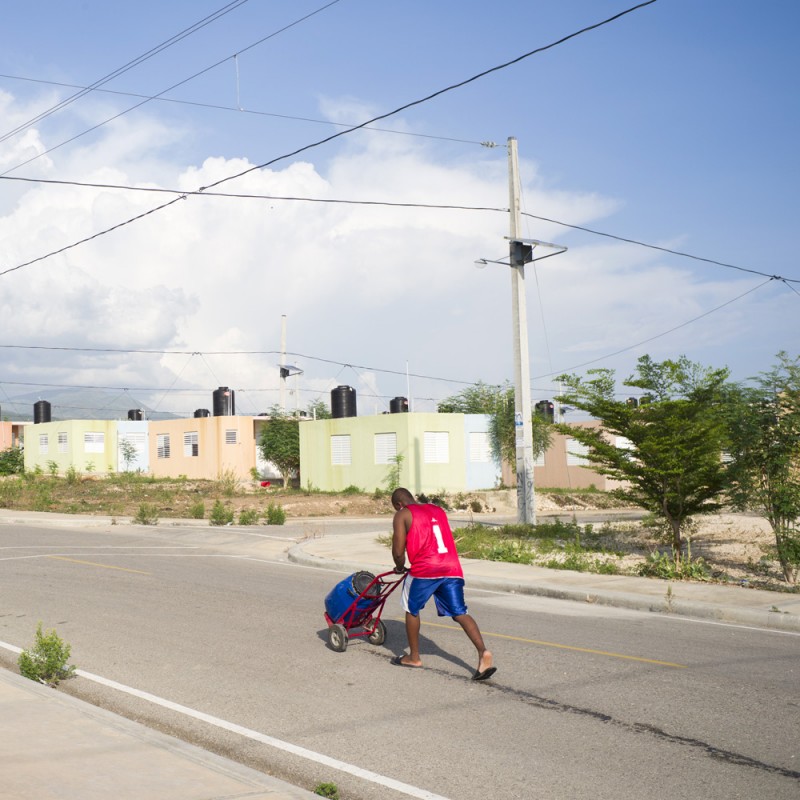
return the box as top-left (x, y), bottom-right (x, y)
top-left (0, 642), bottom-right (448, 800)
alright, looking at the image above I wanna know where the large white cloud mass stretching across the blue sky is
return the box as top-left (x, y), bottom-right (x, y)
top-left (0, 95), bottom-right (779, 418)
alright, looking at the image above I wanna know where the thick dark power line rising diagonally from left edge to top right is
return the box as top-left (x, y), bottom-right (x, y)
top-left (0, 0), bottom-right (656, 276)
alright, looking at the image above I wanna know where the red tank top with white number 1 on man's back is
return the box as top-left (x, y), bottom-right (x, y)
top-left (406, 503), bottom-right (464, 578)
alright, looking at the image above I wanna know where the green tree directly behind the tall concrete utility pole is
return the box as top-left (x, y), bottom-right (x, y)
top-left (438, 381), bottom-right (553, 464)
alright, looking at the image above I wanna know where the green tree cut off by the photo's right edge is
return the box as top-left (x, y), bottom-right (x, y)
top-left (728, 352), bottom-right (800, 583)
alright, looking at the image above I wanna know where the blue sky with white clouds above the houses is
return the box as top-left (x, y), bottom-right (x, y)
top-left (0, 0), bottom-right (800, 416)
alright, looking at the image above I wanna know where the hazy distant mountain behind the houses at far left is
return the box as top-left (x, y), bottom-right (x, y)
top-left (0, 389), bottom-right (180, 422)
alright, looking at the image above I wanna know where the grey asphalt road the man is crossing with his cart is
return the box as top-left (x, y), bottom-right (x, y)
top-left (0, 524), bottom-right (800, 800)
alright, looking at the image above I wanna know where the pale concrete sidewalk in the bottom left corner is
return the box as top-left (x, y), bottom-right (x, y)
top-left (0, 669), bottom-right (317, 800)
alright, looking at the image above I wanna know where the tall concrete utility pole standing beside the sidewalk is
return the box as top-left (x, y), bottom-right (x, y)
top-left (508, 136), bottom-right (536, 525)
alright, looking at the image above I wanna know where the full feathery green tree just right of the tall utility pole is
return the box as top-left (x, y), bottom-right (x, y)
top-left (557, 356), bottom-right (729, 562)
